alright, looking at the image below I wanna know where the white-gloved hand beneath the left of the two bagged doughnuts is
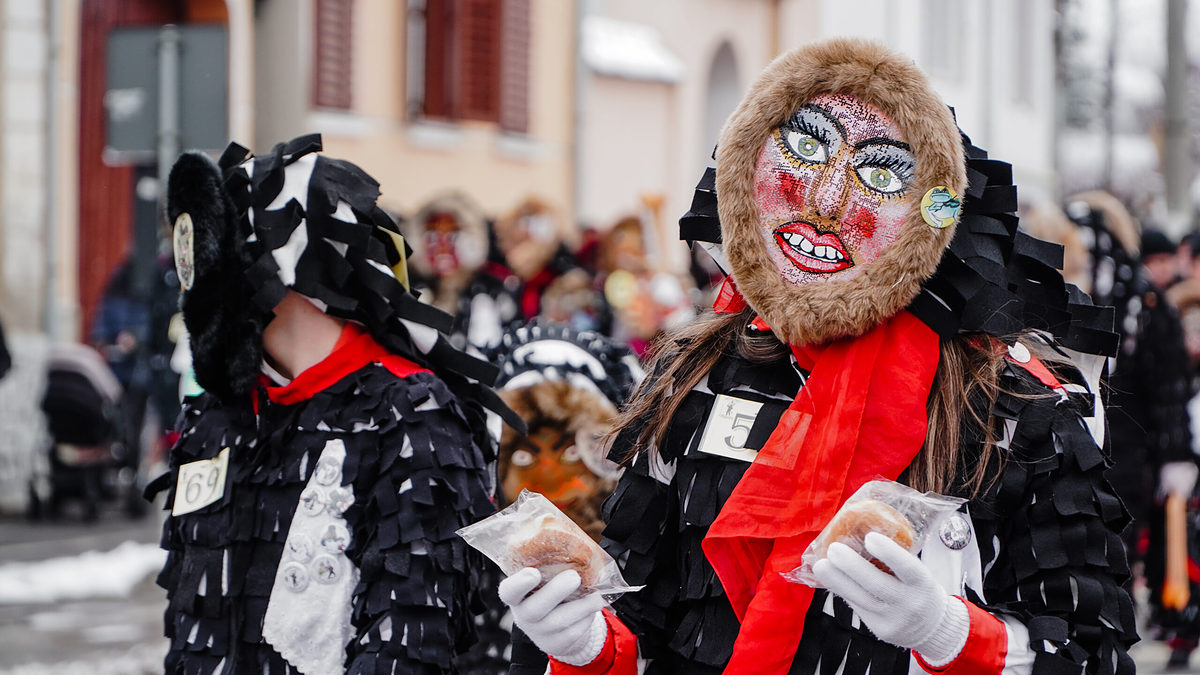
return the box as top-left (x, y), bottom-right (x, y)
top-left (498, 567), bottom-right (608, 665)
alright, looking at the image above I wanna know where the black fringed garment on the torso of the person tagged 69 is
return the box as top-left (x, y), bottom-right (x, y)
top-left (158, 345), bottom-right (494, 673)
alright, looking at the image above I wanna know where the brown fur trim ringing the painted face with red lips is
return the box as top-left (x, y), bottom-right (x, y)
top-left (716, 38), bottom-right (967, 345)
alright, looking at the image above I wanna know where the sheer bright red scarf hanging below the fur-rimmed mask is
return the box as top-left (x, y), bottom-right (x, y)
top-left (703, 311), bottom-right (938, 675)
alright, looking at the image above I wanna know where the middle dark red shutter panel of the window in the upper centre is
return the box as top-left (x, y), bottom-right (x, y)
top-left (457, 0), bottom-right (502, 121)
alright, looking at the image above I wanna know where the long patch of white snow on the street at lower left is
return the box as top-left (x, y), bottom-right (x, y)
top-left (0, 542), bottom-right (167, 604)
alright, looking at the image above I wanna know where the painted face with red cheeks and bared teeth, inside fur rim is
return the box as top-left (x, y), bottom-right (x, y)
top-left (755, 94), bottom-right (916, 285)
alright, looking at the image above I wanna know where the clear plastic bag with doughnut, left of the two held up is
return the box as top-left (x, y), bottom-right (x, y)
top-left (457, 490), bottom-right (641, 602)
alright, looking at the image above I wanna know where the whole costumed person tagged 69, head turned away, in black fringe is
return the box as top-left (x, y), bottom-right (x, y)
top-left (148, 136), bottom-right (520, 674)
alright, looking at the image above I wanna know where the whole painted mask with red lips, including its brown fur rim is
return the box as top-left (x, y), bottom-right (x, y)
top-left (701, 41), bottom-right (967, 345)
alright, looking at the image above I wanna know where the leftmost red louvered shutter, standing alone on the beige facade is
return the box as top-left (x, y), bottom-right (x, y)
top-left (312, 0), bottom-right (354, 110)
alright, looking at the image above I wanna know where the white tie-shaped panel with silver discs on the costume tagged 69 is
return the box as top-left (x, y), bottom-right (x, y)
top-left (263, 438), bottom-right (359, 674)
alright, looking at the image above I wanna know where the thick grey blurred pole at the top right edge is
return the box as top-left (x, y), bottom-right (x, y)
top-left (1163, 0), bottom-right (1193, 238)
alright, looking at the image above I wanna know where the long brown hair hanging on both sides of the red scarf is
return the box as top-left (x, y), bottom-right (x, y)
top-left (613, 307), bottom-right (1003, 497)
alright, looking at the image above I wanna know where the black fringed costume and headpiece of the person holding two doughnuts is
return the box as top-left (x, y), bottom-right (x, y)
top-left (592, 137), bottom-right (1136, 675)
